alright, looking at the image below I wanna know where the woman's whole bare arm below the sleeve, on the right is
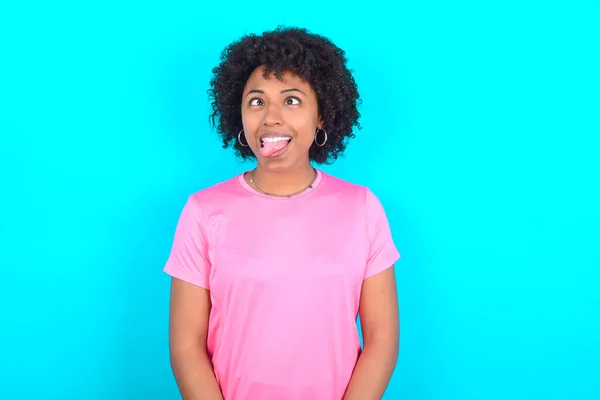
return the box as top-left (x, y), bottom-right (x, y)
top-left (344, 266), bottom-right (400, 400)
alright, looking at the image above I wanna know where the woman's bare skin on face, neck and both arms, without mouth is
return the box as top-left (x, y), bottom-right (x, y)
top-left (170, 67), bottom-right (400, 400)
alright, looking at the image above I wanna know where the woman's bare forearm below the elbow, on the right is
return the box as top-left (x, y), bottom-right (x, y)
top-left (344, 343), bottom-right (398, 400)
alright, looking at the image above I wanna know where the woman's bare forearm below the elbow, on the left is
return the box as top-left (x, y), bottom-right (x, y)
top-left (171, 348), bottom-right (223, 400)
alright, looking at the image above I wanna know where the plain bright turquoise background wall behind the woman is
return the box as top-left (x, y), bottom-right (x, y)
top-left (0, 1), bottom-right (600, 400)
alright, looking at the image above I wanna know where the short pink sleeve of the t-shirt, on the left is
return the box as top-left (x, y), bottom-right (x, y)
top-left (164, 196), bottom-right (210, 289)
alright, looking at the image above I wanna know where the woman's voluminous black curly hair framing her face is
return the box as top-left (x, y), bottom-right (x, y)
top-left (208, 26), bottom-right (361, 164)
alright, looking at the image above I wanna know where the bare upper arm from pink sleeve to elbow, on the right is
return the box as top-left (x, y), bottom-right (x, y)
top-left (359, 266), bottom-right (400, 347)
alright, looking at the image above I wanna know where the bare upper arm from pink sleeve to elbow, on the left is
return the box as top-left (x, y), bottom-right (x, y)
top-left (169, 278), bottom-right (211, 352)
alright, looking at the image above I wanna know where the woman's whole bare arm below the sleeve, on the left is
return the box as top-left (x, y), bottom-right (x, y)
top-left (169, 278), bottom-right (223, 400)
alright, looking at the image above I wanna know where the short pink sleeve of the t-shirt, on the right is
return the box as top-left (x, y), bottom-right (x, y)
top-left (364, 188), bottom-right (400, 279)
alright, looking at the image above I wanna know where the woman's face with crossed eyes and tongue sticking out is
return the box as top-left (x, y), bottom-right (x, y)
top-left (241, 67), bottom-right (322, 170)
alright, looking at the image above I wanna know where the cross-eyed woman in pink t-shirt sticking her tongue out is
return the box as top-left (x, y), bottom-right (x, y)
top-left (165, 28), bottom-right (400, 400)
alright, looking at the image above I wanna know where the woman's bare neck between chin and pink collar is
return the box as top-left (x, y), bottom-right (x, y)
top-left (254, 163), bottom-right (315, 196)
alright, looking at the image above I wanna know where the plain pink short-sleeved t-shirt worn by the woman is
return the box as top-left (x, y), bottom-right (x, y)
top-left (165, 171), bottom-right (400, 400)
